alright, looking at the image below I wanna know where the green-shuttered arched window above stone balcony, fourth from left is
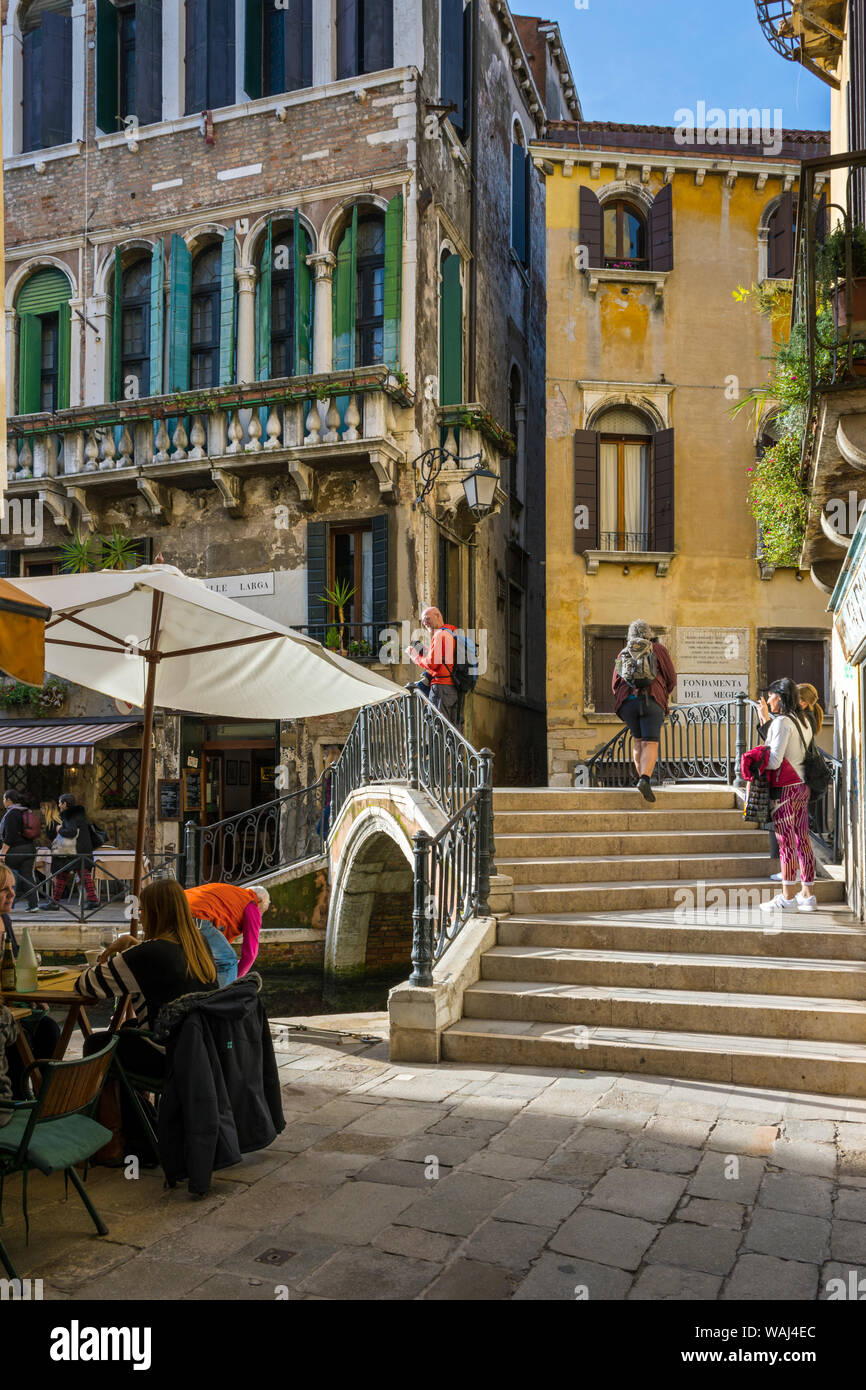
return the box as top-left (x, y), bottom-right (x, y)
top-left (256, 213), bottom-right (313, 381)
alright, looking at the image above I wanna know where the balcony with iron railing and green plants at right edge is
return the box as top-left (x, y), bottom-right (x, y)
top-left (791, 150), bottom-right (866, 594)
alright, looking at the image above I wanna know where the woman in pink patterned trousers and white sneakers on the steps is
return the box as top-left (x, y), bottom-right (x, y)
top-left (760, 677), bottom-right (820, 912)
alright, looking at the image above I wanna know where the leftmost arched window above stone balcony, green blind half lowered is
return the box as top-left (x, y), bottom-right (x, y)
top-left (15, 270), bottom-right (71, 416)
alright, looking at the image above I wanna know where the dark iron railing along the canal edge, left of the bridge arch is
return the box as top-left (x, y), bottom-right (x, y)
top-left (185, 777), bottom-right (323, 888)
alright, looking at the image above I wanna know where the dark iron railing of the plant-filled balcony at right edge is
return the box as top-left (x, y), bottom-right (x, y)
top-left (791, 150), bottom-right (866, 394)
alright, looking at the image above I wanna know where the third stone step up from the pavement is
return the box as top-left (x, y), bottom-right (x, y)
top-left (481, 945), bottom-right (866, 999)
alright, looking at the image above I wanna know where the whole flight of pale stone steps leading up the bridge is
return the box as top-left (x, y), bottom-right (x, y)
top-left (442, 785), bottom-right (866, 1095)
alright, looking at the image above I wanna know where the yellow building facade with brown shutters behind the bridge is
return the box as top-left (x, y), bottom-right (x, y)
top-left (534, 122), bottom-right (833, 785)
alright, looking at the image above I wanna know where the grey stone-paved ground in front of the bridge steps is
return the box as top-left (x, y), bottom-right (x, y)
top-left (3, 1015), bottom-right (866, 1301)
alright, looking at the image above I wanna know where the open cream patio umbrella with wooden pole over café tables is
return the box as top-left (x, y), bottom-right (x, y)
top-left (11, 564), bottom-right (402, 930)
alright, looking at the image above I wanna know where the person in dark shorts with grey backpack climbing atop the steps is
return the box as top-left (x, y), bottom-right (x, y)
top-left (610, 619), bottom-right (677, 801)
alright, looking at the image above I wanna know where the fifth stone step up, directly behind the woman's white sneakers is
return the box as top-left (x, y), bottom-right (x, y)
top-left (513, 874), bottom-right (844, 927)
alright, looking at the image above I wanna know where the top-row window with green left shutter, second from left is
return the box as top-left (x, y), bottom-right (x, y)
top-left (96, 0), bottom-right (163, 133)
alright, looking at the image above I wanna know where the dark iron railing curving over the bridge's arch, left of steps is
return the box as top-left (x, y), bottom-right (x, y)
top-left (331, 691), bottom-right (495, 986)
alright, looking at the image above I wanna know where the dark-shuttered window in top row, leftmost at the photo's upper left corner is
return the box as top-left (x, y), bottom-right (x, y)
top-left (21, 0), bottom-right (72, 150)
